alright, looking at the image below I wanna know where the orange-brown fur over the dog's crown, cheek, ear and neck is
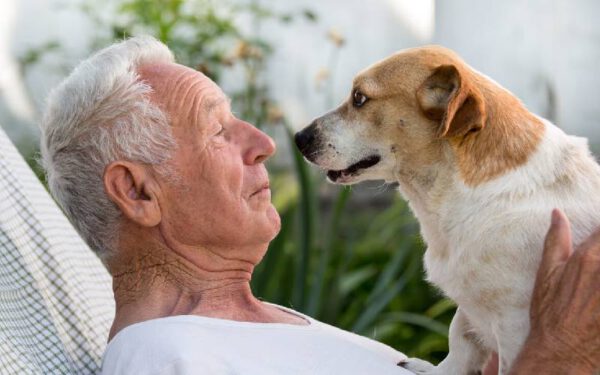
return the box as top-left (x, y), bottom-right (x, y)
top-left (352, 46), bottom-right (544, 186)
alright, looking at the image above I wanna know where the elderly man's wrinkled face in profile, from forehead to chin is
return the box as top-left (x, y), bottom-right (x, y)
top-left (140, 64), bottom-right (280, 261)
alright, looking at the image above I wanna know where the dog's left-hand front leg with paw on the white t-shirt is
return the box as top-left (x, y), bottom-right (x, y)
top-left (401, 309), bottom-right (490, 375)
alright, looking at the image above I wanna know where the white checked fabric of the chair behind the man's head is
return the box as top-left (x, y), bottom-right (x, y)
top-left (0, 129), bottom-right (114, 375)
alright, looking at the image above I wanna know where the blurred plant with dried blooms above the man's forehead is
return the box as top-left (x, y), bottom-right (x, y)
top-left (77, 0), bottom-right (316, 127)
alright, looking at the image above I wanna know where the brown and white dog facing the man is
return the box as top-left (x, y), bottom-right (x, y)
top-left (295, 46), bottom-right (600, 374)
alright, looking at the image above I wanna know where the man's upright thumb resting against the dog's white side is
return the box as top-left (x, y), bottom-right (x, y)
top-left (538, 209), bottom-right (573, 276)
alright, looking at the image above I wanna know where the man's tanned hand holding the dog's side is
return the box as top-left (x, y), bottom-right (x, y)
top-left (511, 210), bottom-right (600, 375)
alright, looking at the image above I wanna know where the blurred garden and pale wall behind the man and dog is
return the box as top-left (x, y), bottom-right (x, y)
top-left (0, 0), bottom-right (600, 362)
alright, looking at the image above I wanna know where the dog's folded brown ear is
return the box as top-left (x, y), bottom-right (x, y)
top-left (417, 65), bottom-right (485, 138)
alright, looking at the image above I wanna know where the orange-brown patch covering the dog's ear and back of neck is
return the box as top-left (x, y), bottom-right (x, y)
top-left (408, 50), bottom-right (544, 186)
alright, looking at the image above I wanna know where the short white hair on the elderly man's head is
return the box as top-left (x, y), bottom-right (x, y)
top-left (41, 37), bottom-right (176, 262)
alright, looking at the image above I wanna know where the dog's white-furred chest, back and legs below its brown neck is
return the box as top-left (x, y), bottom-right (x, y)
top-left (400, 120), bottom-right (600, 374)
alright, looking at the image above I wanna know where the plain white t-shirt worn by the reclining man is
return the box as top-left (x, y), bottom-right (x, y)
top-left (102, 306), bottom-right (411, 375)
